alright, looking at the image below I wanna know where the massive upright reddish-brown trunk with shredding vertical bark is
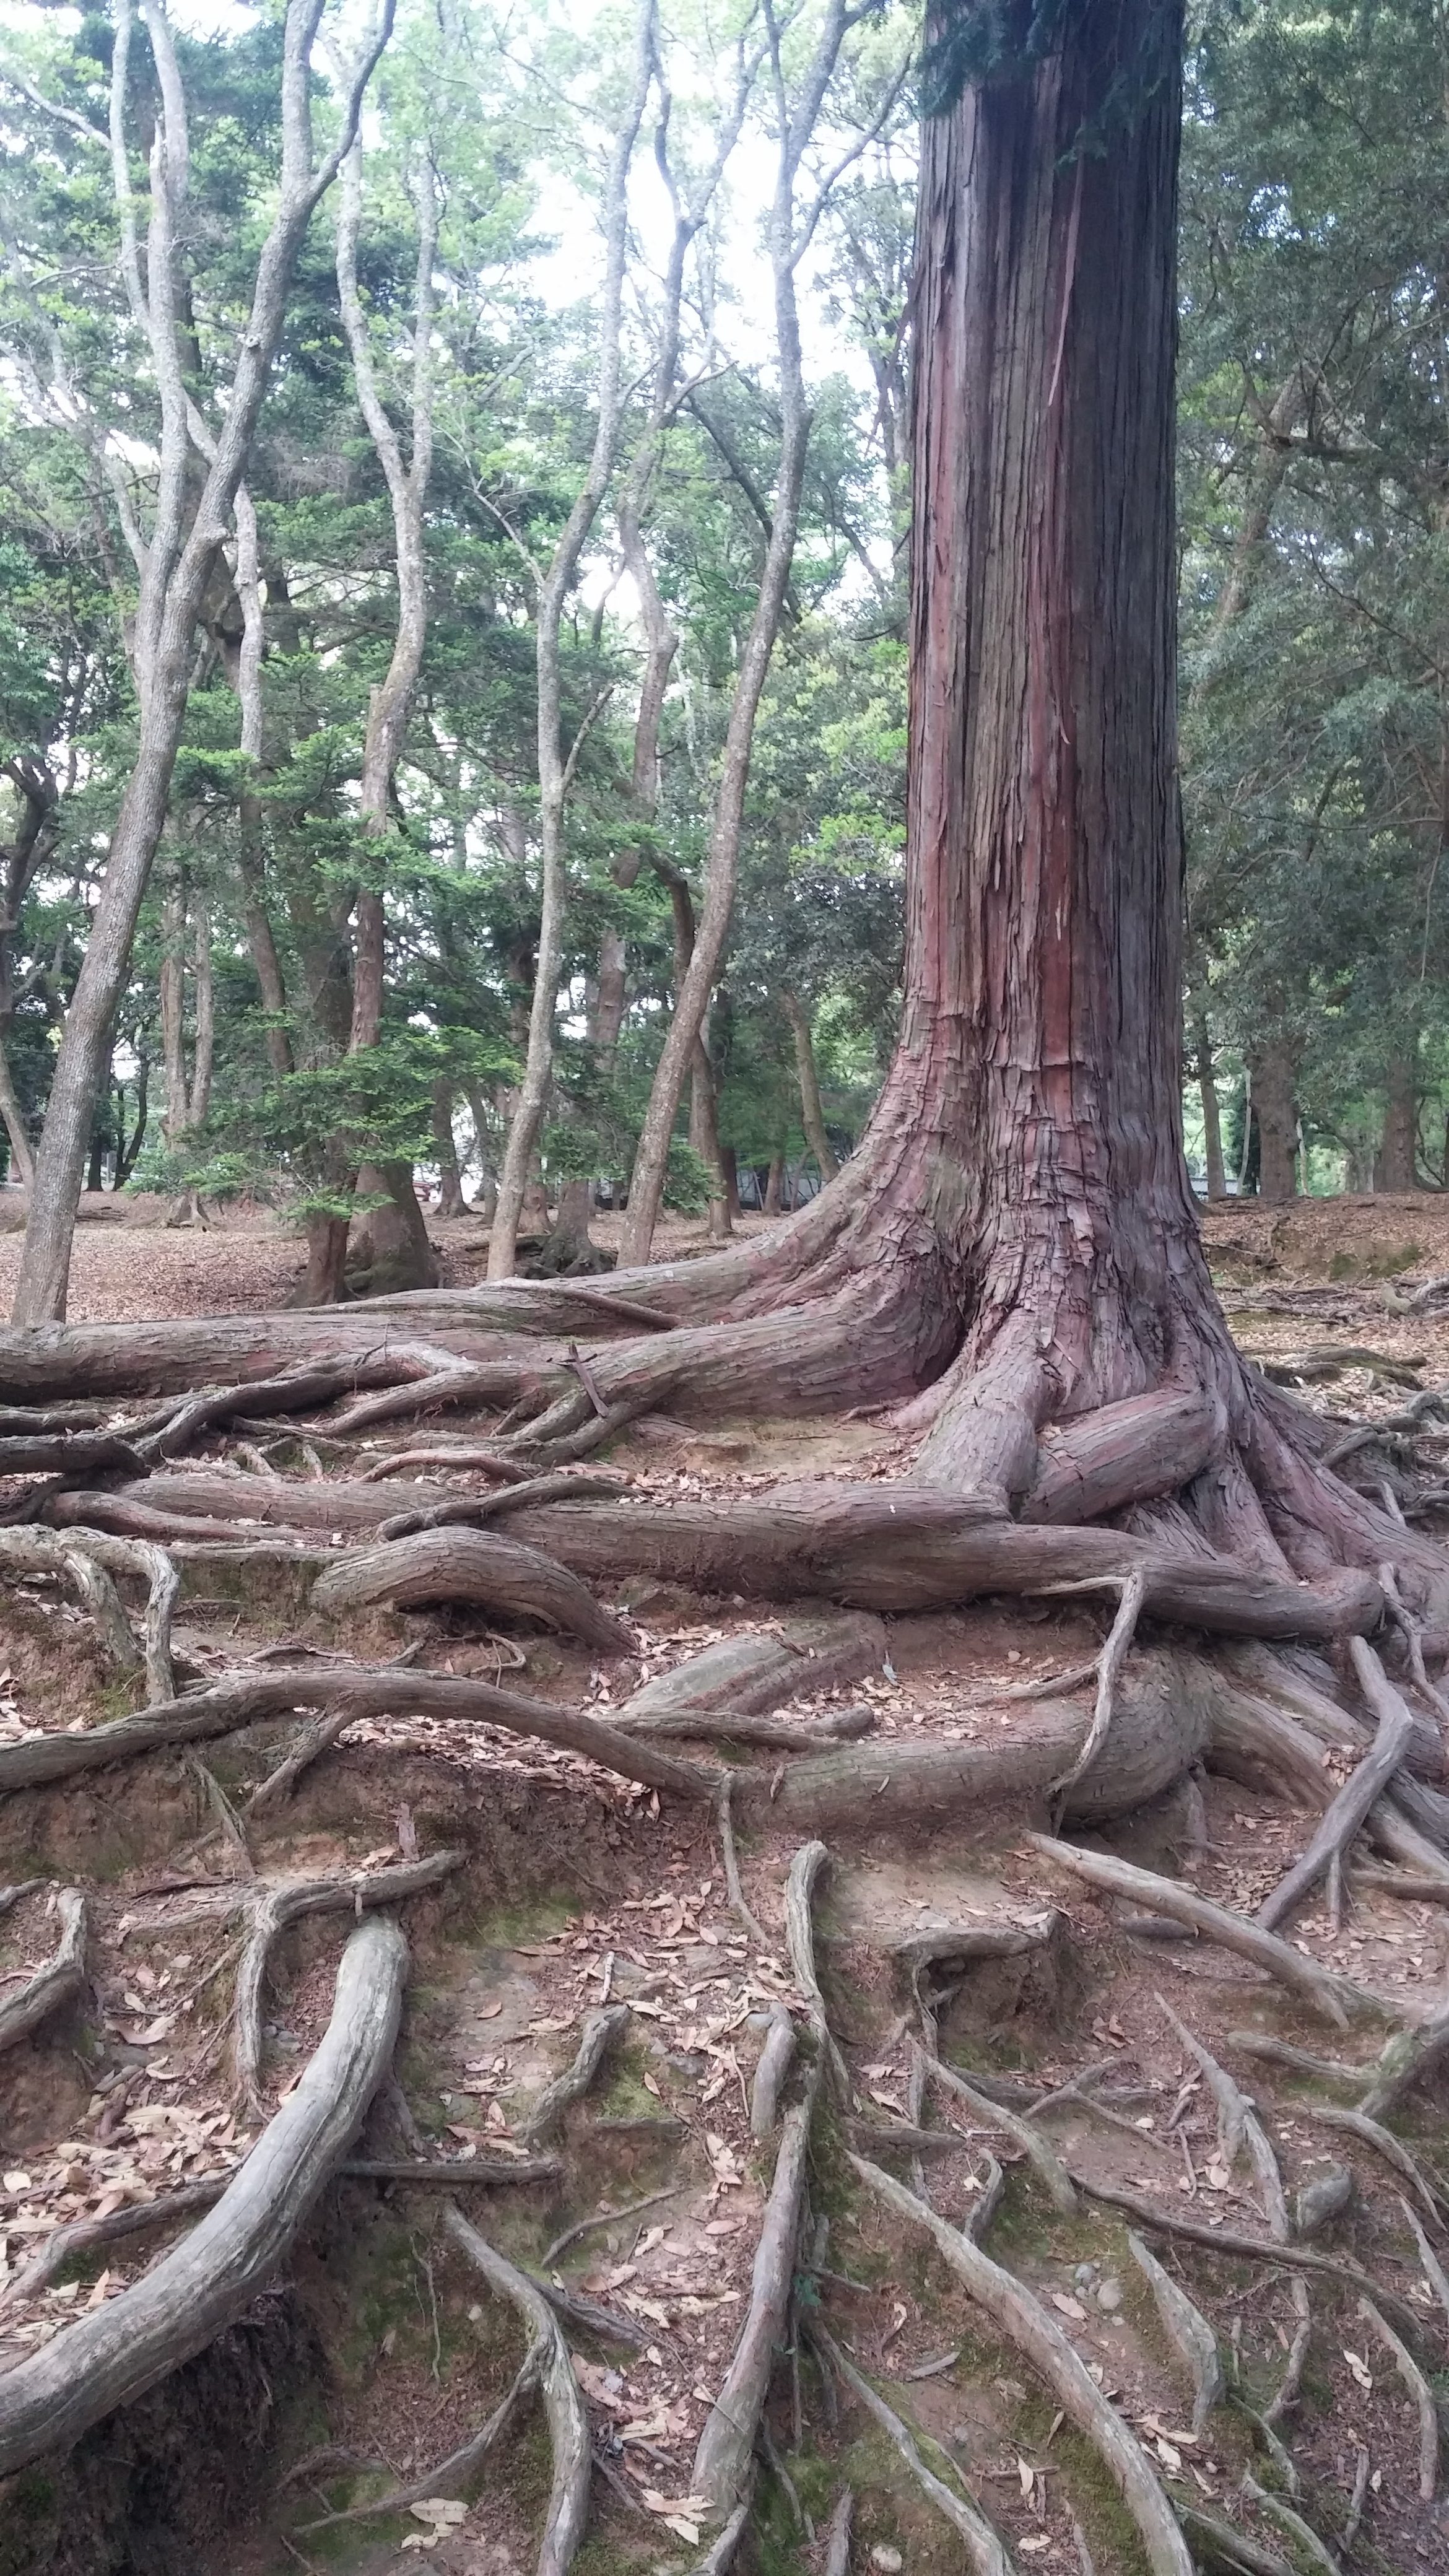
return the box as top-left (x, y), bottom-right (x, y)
top-left (856, 0), bottom-right (1235, 1489)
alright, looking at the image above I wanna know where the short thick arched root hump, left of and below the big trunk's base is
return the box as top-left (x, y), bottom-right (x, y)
top-left (312, 1530), bottom-right (632, 1654)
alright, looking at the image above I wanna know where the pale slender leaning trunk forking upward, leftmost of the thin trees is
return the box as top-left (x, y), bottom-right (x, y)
top-left (13, 0), bottom-right (394, 1324)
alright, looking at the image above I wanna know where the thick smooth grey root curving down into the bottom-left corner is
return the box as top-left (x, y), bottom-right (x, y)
top-left (0, 1919), bottom-right (407, 2478)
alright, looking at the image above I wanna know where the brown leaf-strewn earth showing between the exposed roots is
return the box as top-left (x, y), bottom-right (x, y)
top-left (0, 1201), bottom-right (1449, 2576)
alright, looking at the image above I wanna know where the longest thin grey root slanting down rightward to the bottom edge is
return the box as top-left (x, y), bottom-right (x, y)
top-left (851, 2156), bottom-right (1191, 2576)
